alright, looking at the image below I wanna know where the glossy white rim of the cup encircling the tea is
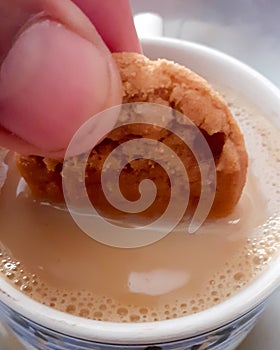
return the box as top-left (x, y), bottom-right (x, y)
top-left (0, 37), bottom-right (280, 344)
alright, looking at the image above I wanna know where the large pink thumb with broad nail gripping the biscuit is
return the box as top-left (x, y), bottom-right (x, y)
top-left (0, 0), bottom-right (121, 157)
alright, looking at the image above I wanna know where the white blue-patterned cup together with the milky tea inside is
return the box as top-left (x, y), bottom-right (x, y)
top-left (0, 37), bottom-right (280, 350)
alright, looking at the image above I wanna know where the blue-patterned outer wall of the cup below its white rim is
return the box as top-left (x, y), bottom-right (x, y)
top-left (0, 302), bottom-right (264, 350)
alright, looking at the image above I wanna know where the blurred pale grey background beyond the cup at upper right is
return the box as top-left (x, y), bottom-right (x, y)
top-left (131, 0), bottom-right (280, 86)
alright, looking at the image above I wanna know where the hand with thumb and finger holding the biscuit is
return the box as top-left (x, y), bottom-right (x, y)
top-left (0, 0), bottom-right (141, 157)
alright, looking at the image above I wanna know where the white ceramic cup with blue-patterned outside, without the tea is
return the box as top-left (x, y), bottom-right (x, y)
top-left (0, 38), bottom-right (280, 350)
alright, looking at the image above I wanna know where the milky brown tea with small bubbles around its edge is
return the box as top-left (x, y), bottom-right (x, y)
top-left (0, 95), bottom-right (280, 322)
